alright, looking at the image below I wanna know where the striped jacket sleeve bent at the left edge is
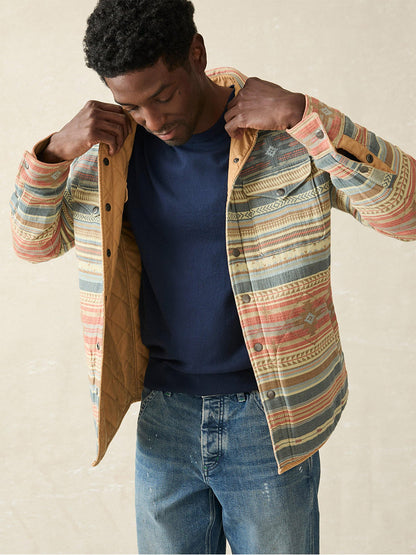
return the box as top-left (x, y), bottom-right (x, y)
top-left (10, 139), bottom-right (74, 262)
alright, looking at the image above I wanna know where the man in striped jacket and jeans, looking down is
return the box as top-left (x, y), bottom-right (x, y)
top-left (12, 0), bottom-right (416, 553)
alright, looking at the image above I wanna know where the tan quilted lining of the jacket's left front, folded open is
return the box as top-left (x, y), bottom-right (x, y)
top-left (94, 132), bottom-right (148, 465)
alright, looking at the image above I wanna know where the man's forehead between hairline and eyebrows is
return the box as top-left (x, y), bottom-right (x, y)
top-left (105, 60), bottom-right (186, 104)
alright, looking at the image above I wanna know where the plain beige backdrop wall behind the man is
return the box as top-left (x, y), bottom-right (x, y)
top-left (0, 0), bottom-right (416, 553)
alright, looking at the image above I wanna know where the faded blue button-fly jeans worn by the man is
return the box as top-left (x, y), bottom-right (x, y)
top-left (136, 390), bottom-right (320, 553)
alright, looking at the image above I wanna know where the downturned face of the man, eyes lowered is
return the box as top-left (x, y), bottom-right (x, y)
top-left (105, 59), bottom-right (204, 146)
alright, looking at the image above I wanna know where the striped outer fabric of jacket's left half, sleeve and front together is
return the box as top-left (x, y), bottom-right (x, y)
top-left (11, 141), bottom-right (104, 427)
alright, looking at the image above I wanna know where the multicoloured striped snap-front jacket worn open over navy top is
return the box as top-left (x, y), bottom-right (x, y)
top-left (11, 68), bottom-right (416, 473)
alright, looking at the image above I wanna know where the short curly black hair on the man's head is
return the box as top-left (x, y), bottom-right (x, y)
top-left (84, 0), bottom-right (196, 79)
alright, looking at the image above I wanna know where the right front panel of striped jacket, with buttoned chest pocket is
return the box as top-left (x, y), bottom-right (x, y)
top-left (228, 126), bottom-right (347, 470)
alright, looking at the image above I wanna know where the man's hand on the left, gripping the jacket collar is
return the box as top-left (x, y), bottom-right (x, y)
top-left (38, 100), bottom-right (131, 164)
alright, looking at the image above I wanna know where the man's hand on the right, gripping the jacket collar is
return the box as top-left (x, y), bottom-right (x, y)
top-left (224, 77), bottom-right (305, 139)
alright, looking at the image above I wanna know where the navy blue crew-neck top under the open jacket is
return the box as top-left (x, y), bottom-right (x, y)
top-left (126, 99), bottom-right (257, 395)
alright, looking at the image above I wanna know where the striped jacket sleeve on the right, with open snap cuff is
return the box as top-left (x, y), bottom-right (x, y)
top-left (288, 96), bottom-right (416, 241)
